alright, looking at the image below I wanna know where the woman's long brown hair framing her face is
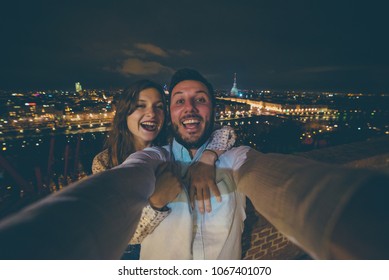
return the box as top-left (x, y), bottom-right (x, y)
top-left (105, 80), bottom-right (168, 168)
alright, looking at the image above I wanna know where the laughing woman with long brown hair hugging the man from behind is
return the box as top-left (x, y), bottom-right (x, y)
top-left (92, 80), bottom-right (235, 259)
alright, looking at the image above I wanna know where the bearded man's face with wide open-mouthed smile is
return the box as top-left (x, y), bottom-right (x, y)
top-left (170, 80), bottom-right (213, 149)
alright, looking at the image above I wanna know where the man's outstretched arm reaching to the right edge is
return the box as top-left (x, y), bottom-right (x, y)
top-left (237, 150), bottom-right (389, 259)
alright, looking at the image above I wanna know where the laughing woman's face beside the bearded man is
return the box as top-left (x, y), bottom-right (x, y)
top-left (127, 88), bottom-right (165, 151)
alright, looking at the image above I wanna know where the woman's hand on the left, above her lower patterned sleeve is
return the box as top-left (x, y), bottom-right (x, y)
top-left (149, 162), bottom-right (182, 210)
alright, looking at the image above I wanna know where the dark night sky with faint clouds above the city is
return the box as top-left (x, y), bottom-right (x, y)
top-left (0, 0), bottom-right (389, 93)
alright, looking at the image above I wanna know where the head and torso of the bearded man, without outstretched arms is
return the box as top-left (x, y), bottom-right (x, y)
top-left (119, 69), bottom-right (250, 259)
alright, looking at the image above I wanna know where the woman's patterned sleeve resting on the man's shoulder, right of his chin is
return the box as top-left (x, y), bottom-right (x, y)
top-left (207, 125), bottom-right (236, 151)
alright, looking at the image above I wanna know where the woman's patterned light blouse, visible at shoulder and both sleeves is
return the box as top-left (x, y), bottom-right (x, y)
top-left (92, 126), bottom-right (236, 244)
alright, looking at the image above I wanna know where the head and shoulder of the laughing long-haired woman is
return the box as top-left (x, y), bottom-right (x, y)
top-left (92, 80), bottom-right (166, 173)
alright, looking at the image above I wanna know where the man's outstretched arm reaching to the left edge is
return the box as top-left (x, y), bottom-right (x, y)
top-left (0, 158), bottom-right (161, 259)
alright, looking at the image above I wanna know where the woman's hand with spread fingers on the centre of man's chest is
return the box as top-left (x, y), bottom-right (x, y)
top-left (186, 151), bottom-right (221, 213)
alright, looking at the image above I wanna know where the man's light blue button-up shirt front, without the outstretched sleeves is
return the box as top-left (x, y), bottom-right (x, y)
top-left (124, 141), bottom-right (250, 259)
